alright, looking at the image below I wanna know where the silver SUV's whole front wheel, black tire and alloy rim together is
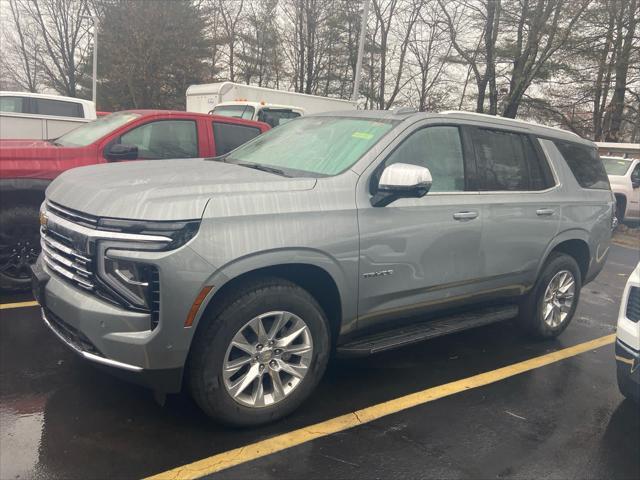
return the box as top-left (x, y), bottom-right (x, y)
top-left (187, 278), bottom-right (331, 426)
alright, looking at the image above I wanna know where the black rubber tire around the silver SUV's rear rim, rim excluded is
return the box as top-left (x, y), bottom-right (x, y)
top-left (532, 254), bottom-right (582, 338)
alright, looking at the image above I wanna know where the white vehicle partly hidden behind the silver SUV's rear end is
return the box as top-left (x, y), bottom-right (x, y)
top-left (600, 157), bottom-right (640, 222)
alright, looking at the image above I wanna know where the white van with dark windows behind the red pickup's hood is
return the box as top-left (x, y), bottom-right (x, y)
top-left (0, 91), bottom-right (96, 140)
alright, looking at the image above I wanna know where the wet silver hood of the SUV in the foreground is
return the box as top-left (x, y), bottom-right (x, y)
top-left (47, 159), bottom-right (316, 220)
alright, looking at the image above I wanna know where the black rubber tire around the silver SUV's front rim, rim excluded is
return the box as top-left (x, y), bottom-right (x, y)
top-left (190, 286), bottom-right (330, 426)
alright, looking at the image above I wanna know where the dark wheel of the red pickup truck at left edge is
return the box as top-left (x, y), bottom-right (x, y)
top-left (0, 206), bottom-right (40, 290)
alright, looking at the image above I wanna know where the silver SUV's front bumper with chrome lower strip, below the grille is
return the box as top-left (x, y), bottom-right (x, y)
top-left (32, 248), bottom-right (212, 393)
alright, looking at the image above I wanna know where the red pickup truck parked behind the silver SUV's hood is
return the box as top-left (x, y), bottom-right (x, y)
top-left (0, 110), bottom-right (270, 290)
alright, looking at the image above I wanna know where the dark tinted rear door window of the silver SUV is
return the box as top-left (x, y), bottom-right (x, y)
top-left (472, 128), bottom-right (553, 192)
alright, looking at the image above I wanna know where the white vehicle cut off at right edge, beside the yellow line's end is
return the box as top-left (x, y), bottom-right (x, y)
top-left (616, 263), bottom-right (640, 402)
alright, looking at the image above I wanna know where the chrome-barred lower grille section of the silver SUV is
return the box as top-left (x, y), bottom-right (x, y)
top-left (40, 228), bottom-right (95, 290)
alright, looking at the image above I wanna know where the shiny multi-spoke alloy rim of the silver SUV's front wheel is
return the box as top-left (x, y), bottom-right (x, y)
top-left (222, 311), bottom-right (313, 408)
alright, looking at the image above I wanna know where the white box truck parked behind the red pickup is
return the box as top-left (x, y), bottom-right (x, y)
top-left (187, 82), bottom-right (357, 127)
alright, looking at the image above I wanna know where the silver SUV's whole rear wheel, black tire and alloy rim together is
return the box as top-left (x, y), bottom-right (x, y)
top-left (519, 252), bottom-right (582, 339)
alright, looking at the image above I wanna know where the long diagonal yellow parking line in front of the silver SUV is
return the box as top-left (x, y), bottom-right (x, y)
top-left (147, 334), bottom-right (616, 480)
